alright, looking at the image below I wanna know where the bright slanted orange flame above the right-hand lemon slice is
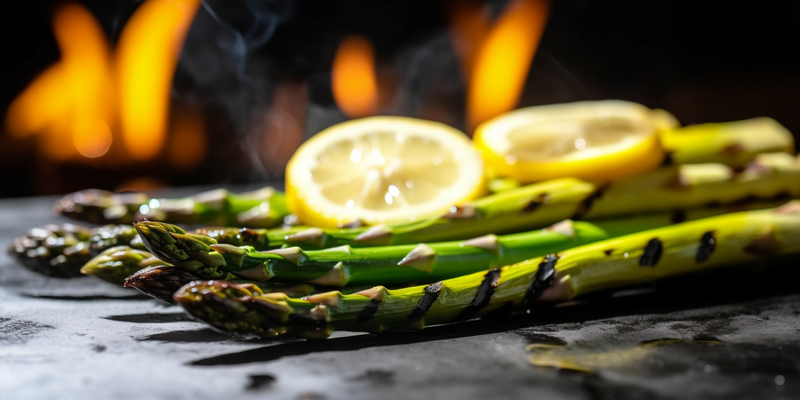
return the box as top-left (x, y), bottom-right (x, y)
top-left (467, 0), bottom-right (549, 128)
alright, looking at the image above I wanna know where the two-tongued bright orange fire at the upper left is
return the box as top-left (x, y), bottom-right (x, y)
top-left (6, 0), bottom-right (204, 161)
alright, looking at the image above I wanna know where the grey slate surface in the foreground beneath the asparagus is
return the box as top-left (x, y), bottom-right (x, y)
top-left (0, 192), bottom-right (800, 400)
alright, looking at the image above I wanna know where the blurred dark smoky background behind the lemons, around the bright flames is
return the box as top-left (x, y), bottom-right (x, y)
top-left (0, 0), bottom-right (800, 197)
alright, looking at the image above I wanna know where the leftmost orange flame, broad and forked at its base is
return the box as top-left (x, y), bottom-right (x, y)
top-left (6, 4), bottom-right (114, 160)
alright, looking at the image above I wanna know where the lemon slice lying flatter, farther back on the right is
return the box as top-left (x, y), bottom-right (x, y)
top-left (474, 100), bottom-right (672, 183)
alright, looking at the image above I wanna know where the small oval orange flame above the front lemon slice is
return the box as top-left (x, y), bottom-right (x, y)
top-left (331, 36), bottom-right (378, 118)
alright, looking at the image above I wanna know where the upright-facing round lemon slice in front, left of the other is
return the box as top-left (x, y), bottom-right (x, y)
top-left (286, 116), bottom-right (484, 227)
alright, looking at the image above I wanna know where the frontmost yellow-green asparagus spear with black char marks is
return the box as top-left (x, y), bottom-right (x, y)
top-left (174, 202), bottom-right (800, 338)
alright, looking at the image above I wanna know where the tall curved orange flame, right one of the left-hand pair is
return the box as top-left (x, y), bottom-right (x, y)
top-left (116, 0), bottom-right (200, 159)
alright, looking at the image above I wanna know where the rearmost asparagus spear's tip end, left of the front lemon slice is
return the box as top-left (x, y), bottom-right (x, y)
top-left (53, 187), bottom-right (289, 228)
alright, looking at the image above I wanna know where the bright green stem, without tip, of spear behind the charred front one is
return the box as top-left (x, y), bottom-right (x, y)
top-left (167, 220), bottom-right (607, 287)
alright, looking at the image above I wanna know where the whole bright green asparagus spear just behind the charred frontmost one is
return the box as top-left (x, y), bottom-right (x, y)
top-left (137, 198), bottom-right (780, 287)
